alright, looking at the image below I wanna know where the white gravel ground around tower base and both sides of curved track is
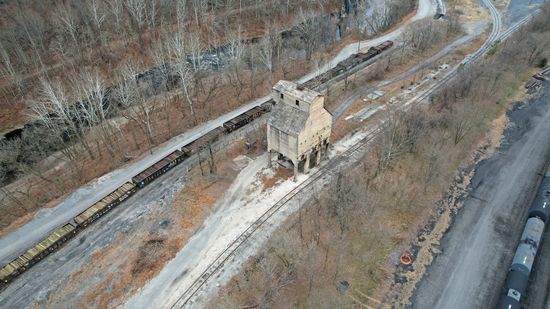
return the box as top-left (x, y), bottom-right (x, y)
top-left (126, 118), bottom-right (384, 309)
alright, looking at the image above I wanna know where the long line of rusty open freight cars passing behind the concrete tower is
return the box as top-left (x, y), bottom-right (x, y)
top-left (0, 41), bottom-right (393, 288)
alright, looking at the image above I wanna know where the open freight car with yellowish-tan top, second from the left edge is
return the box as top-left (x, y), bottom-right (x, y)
top-left (74, 182), bottom-right (136, 227)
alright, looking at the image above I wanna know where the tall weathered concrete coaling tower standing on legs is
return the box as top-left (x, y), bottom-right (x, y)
top-left (267, 80), bottom-right (332, 178)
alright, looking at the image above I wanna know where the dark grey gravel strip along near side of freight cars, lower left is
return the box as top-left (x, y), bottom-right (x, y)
top-left (0, 152), bottom-right (192, 309)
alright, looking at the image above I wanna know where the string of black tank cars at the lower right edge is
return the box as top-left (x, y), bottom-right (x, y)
top-left (497, 168), bottom-right (550, 309)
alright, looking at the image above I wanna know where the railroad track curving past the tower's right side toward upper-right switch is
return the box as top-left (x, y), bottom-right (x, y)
top-left (170, 0), bottom-right (548, 309)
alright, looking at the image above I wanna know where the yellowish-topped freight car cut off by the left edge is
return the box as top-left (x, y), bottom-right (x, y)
top-left (0, 223), bottom-right (76, 286)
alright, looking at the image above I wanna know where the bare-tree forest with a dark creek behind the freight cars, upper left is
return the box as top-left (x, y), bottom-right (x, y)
top-left (0, 0), bottom-right (413, 230)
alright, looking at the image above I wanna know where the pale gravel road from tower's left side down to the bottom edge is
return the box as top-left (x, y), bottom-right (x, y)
top-left (126, 154), bottom-right (267, 309)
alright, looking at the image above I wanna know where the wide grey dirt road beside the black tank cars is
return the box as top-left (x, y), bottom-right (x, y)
top-left (412, 82), bottom-right (550, 309)
